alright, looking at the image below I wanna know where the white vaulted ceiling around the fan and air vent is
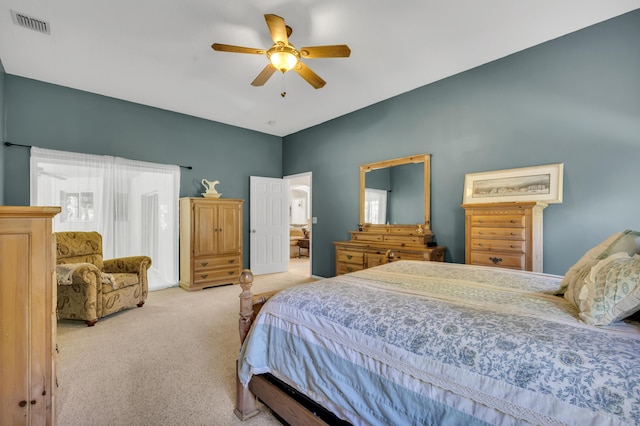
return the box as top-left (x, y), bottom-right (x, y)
top-left (0, 0), bottom-right (640, 136)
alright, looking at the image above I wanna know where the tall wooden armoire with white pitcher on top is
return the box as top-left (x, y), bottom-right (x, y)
top-left (180, 198), bottom-right (243, 291)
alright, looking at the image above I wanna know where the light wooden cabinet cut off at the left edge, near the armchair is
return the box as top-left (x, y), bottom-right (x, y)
top-left (0, 206), bottom-right (60, 425)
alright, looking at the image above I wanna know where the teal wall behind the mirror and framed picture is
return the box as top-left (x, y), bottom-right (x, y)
top-left (283, 10), bottom-right (640, 276)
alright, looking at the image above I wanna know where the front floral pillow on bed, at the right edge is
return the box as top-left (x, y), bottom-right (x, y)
top-left (579, 252), bottom-right (640, 325)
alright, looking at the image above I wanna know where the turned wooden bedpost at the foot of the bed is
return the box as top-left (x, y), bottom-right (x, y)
top-left (233, 269), bottom-right (258, 420)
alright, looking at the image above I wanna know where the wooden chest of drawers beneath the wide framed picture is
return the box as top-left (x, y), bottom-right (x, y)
top-left (462, 202), bottom-right (547, 272)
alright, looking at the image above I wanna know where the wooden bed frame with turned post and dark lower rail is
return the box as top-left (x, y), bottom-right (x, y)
top-left (234, 269), bottom-right (350, 425)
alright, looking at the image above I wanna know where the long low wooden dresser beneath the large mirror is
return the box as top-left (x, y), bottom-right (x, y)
top-left (333, 225), bottom-right (446, 275)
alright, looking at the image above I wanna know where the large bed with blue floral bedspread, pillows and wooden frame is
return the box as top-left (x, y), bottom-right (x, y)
top-left (236, 231), bottom-right (640, 425)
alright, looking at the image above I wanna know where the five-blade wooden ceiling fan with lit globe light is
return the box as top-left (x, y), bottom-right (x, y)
top-left (211, 14), bottom-right (351, 90)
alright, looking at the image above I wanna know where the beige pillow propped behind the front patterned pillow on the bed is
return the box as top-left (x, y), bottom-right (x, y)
top-left (554, 229), bottom-right (640, 300)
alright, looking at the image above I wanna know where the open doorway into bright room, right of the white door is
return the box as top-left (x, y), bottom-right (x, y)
top-left (284, 172), bottom-right (312, 276)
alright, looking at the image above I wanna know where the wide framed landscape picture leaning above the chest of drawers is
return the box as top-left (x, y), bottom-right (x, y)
top-left (462, 163), bottom-right (564, 204)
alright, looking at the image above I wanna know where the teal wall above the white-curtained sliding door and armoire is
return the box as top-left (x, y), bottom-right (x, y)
top-left (2, 74), bottom-right (282, 266)
